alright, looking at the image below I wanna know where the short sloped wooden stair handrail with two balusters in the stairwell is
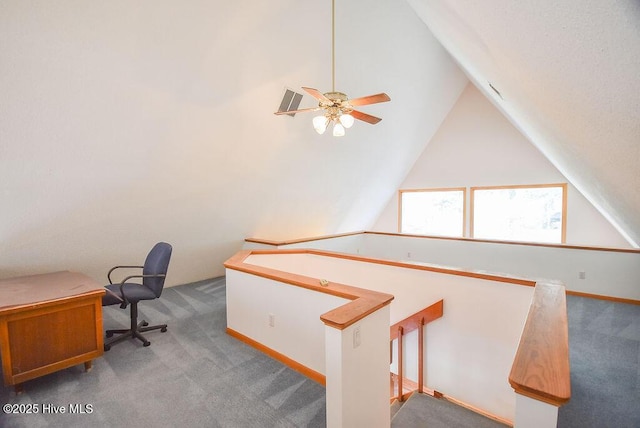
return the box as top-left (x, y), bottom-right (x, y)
top-left (389, 300), bottom-right (444, 401)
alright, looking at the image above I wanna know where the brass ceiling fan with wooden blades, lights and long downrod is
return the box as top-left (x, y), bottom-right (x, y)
top-left (275, 0), bottom-right (391, 137)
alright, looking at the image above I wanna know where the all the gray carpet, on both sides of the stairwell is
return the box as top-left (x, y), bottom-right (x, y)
top-left (0, 278), bottom-right (640, 428)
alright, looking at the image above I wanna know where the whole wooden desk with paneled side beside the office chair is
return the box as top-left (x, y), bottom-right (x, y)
top-left (0, 271), bottom-right (105, 392)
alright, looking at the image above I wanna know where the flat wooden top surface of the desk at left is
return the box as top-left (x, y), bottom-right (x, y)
top-left (0, 271), bottom-right (105, 311)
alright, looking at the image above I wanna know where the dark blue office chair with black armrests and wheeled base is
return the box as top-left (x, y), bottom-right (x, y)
top-left (102, 242), bottom-right (172, 351)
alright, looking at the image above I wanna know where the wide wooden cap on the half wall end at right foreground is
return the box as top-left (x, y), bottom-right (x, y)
top-left (509, 283), bottom-right (571, 407)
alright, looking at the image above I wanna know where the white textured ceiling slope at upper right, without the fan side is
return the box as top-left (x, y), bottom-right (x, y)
top-left (408, 0), bottom-right (640, 246)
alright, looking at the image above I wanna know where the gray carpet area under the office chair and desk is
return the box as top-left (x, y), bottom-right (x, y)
top-left (0, 278), bottom-right (326, 428)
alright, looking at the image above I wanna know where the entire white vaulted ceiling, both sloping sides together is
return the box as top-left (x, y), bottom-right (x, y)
top-left (0, 0), bottom-right (640, 283)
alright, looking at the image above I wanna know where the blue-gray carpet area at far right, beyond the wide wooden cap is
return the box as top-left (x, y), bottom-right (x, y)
top-left (558, 296), bottom-right (640, 428)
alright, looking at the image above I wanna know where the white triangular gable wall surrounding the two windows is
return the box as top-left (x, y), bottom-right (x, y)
top-left (371, 83), bottom-right (631, 248)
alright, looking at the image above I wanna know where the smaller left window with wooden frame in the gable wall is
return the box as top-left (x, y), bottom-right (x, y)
top-left (399, 188), bottom-right (466, 237)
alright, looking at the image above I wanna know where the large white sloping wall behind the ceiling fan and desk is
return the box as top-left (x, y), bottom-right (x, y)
top-left (0, 0), bottom-right (467, 285)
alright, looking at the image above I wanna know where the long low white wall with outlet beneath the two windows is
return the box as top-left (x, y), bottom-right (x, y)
top-left (359, 233), bottom-right (640, 301)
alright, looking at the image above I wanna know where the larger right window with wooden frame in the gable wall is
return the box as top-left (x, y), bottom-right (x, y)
top-left (471, 184), bottom-right (567, 243)
